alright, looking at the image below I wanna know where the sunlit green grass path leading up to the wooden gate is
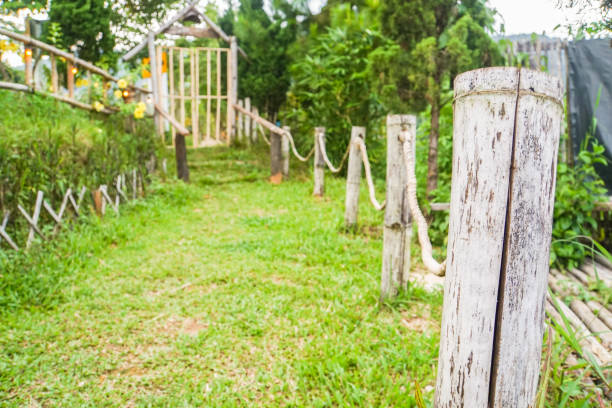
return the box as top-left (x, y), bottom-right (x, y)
top-left (0, 149), bottom-right (442, 407)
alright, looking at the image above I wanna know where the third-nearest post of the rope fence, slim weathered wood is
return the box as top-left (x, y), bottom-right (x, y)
top-left (344, 126), bottom-right (365, 228)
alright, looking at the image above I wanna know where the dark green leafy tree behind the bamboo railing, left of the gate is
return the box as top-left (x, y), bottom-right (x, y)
top-left (49, 0), bottom-right (115, 63)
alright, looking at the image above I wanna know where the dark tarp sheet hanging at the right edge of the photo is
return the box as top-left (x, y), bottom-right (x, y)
top-left (567, 39), bottom-right (612, 192)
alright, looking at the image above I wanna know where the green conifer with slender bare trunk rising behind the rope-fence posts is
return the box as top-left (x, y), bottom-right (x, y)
top-left (375, 0), bottom-right (502, 197)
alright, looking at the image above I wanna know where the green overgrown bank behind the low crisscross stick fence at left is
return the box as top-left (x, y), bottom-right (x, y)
top-left (0, 91), bottom-right (159, 214)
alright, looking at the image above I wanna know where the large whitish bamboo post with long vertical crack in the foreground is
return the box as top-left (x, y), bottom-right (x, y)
top-left (435, 67), bottom-right (563, 408)
